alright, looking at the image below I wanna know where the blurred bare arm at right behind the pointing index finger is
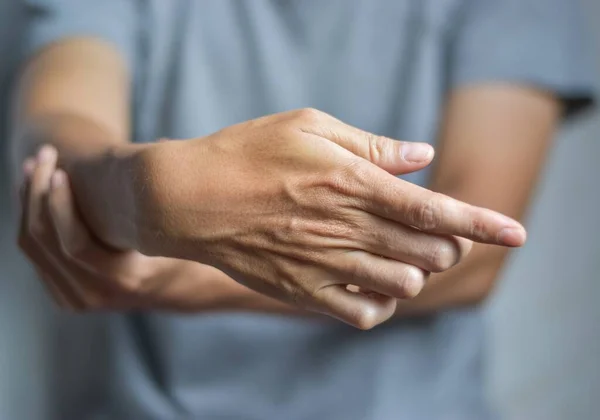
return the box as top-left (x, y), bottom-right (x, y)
top-left (397, 84), bottom-right (561, 316)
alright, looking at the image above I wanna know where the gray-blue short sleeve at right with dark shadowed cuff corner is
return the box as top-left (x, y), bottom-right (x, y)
top-left (449, 0), bottom-right (597, 115)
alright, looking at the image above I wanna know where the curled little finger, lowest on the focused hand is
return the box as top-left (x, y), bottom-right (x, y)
top-left (315, 284), bottom-right (396, 330)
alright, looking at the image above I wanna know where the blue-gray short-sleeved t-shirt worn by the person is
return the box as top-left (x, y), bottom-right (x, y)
top-left (26, 0), bottom-right (592, 420)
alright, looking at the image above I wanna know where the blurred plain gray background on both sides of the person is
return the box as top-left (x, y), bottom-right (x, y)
top-left (0, 0), bottom-right (600, 420)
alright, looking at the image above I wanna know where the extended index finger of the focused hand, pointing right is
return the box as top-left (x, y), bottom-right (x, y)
top-left (355, 165), bottom-right (526, 247)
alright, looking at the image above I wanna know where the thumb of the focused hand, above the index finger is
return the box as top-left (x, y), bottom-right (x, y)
top-left (298, 111), bottom-right (434, 175)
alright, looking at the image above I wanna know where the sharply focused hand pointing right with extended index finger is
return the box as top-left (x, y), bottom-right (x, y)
top-left (136, 109), bottom-right (525, 328)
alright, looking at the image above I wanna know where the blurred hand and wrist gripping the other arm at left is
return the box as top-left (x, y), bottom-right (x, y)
top-left (19, 147), bottom-right (216, 311)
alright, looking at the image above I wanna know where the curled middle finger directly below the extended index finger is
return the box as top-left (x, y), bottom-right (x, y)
top-left (356, 216), bottom-right (473, 273)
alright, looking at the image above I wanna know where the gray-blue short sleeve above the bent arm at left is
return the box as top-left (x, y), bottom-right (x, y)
top-left (23, 0), bottom-right (139, 70)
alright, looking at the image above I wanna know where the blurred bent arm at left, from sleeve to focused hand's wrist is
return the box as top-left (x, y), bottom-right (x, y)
top-left (11, 38), bottom-right (142, 248)
